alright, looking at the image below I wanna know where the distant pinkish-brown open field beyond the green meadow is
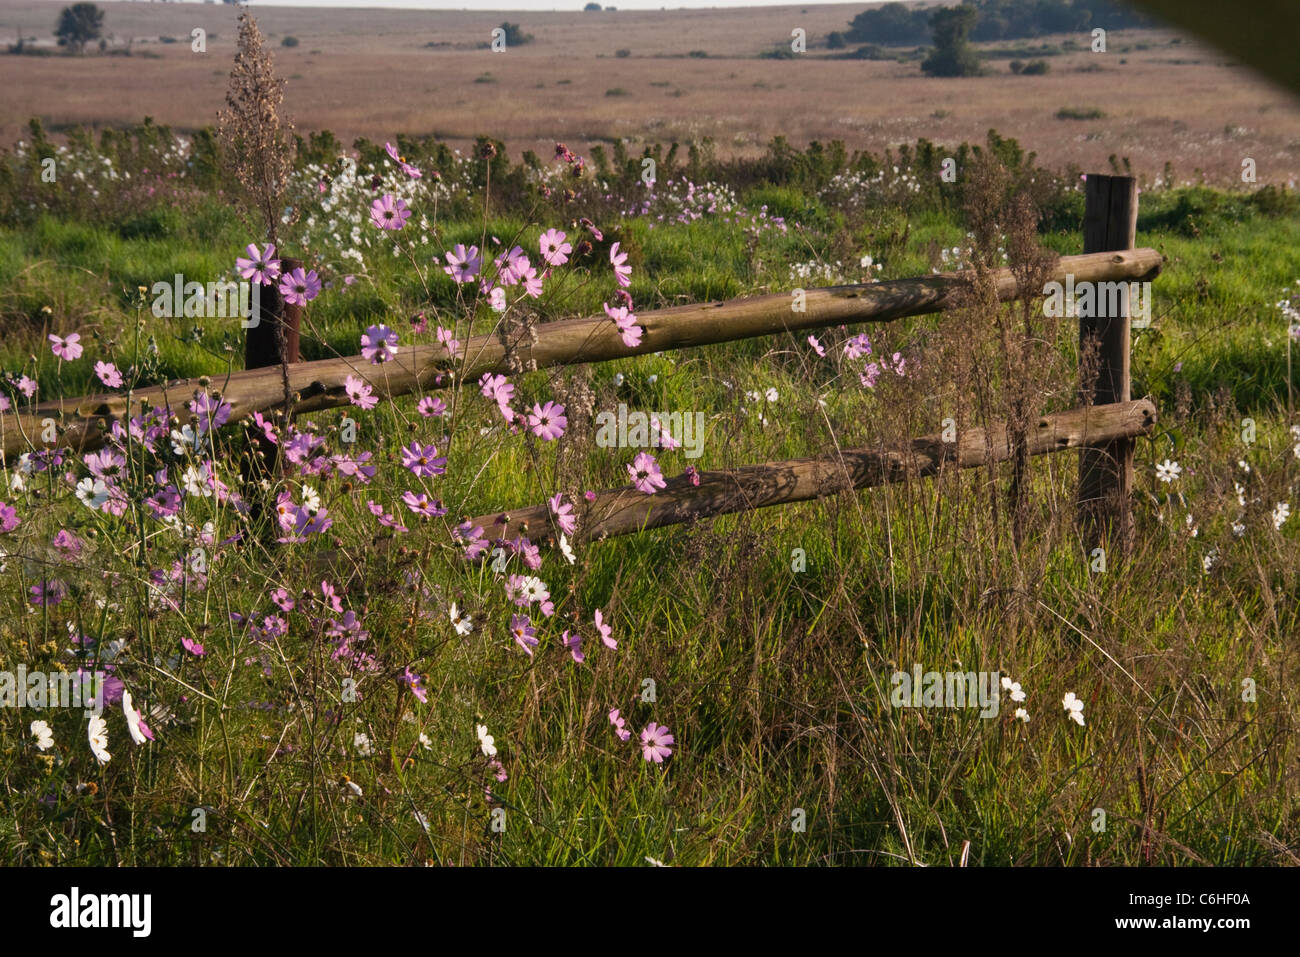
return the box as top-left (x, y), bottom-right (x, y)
top-left (0, 0), bottom-right (1300, 183)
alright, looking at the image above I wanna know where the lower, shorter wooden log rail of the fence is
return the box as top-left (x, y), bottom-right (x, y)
top-left (472, 399), bottom-right (1156, 542)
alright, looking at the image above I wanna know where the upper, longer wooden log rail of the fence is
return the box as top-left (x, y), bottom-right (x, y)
top-left (0, 248), bottom-right (1161, 462)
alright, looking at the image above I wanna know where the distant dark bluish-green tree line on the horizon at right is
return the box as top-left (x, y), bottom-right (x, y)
top-left (844, 0), bottom-right (1154, 47)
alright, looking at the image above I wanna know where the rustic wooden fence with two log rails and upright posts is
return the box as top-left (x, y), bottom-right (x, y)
top-left (0, 176), bottom-right (1162, 547)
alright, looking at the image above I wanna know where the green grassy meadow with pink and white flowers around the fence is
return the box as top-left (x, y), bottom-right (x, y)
top-left (0, 1), bottom-right (1300, 866)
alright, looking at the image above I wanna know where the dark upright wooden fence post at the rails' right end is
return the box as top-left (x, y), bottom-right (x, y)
top-left (1078, 173), bottom-right (1138, 554)
